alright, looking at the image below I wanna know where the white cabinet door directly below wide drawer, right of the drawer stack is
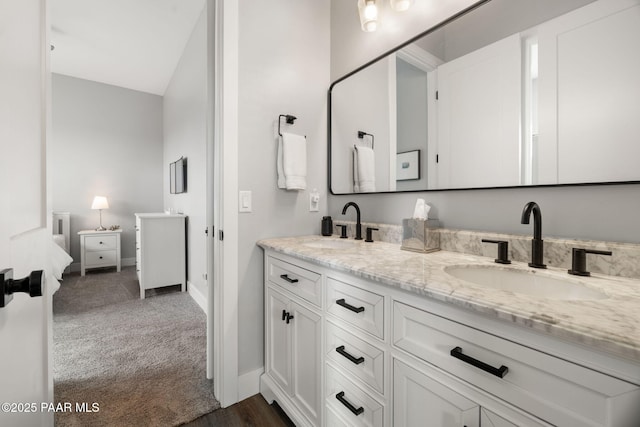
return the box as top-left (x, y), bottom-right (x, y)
top-left (393, 359), bottom-right (480, 427)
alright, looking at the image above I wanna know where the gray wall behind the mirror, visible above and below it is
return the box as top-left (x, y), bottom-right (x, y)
top-left (329, 0), bottom-right (640, 243)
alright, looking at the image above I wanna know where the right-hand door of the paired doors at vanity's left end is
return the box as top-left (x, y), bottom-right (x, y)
top-left (284, 301), bottom-right (322, 422)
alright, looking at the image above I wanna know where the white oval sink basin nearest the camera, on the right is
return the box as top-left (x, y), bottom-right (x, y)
top-left (445, 265), bottom-right (607, 301)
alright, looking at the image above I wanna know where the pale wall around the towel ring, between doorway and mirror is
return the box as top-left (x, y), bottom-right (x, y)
top-left (238, 0), bottom-right (330, 375)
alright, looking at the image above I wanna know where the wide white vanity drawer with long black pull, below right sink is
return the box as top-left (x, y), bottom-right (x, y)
top-left (392, 302), bottom-right (640, 427)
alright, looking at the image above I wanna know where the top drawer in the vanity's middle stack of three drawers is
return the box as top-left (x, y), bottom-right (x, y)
top-left (327, 278), bottom-right (384, 339)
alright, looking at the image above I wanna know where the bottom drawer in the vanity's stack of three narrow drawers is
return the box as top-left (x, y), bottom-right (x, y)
top-left (325, 365), bottom-right (384, 427)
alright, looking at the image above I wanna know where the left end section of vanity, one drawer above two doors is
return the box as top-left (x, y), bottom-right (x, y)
top-left (260, 257), bottom-right (322, 426)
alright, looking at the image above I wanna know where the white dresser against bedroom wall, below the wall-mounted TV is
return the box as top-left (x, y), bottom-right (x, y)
top-left (135, 213), bottom-right (187, 298)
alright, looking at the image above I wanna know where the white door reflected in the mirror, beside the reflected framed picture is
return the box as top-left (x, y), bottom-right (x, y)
top-left (437, 34), bottom-right (522, 188)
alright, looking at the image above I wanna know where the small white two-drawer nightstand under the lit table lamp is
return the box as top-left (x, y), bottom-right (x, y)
top-left (78, 229), bottom-right (122, 276)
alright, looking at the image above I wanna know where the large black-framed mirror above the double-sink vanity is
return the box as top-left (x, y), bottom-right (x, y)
top-left (329, 0), bottom-right (640, 194)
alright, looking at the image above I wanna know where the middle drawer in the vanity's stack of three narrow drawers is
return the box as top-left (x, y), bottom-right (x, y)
top-left (326, 322), bottom-right (385, 394)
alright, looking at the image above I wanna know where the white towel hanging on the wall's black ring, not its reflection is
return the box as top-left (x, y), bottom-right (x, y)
top-left (277, 132), bottom-right (307, 190)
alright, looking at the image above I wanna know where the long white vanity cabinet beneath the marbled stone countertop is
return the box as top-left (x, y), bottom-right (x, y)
top-left (261, 249), bottom-right (640, 427)
